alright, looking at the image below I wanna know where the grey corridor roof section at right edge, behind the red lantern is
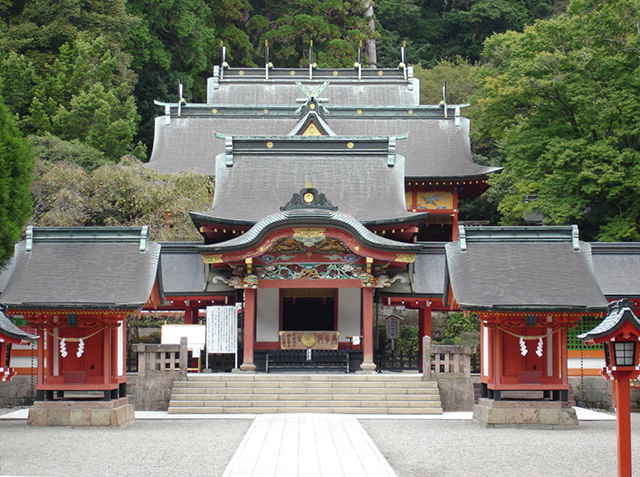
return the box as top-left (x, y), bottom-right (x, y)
top-left (591, 242), bottom-right (640, 299)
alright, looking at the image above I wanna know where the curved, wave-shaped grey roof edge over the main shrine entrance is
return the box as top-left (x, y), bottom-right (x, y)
top-left (200, 209), bottom-right (422, 253)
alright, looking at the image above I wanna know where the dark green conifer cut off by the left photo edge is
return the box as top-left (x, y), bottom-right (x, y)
top-left (0, 93), bottom-right (33, 264)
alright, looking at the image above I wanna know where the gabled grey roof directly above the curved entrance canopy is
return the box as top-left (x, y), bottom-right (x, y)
top-left (191, 136), bottom-right (421, 226)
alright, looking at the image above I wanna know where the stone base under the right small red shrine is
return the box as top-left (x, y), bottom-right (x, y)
top-left (473, 398), bottom-right (578, 429)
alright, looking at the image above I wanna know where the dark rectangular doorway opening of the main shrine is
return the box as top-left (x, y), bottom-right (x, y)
top-left (282, 288), bottom-right (337, 331)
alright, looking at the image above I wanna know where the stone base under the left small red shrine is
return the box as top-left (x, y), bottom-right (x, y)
top-left (27, 397), bottom-right (135, 429)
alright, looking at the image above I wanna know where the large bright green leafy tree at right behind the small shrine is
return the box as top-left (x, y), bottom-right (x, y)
top-left (474, 0), bottom-right (640, 241)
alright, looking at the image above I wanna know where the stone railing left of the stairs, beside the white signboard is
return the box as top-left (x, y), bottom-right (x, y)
top-left (133, 337), bottom-right (188, 411)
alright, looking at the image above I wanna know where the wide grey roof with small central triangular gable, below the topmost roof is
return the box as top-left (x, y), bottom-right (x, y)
top-left (149, 114), bottom-right (500, 179)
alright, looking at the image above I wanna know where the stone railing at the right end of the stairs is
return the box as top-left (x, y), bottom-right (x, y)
top-left (422, 336), bottom-right (476, 411)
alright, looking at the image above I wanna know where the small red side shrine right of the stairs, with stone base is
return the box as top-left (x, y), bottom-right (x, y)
top-left (444, 226), bottom-right (607, 429)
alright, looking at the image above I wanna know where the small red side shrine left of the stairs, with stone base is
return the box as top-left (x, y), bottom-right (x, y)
top-left (2, 227), bottom-right (163, 427)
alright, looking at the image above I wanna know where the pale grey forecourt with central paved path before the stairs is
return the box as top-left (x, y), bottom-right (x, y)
top-left (0, 410), bottom-right (640, 477)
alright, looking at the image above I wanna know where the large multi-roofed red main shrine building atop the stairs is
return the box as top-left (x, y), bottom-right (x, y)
top-left (149, 63), bottom-right (499, 370)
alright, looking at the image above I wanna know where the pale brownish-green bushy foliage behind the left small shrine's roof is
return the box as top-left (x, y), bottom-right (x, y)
top-left (32, 156), bottom-right (212, 241)
